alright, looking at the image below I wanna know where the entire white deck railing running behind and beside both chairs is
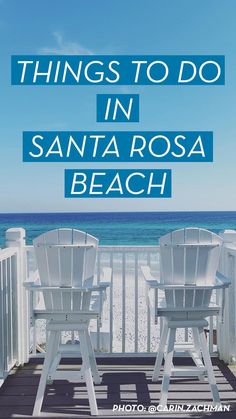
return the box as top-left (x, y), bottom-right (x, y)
top-left (0, 229), bottom-right (236, 388)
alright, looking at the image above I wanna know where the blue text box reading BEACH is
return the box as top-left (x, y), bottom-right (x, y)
top-left (65, 169), bottom-right (171, 198)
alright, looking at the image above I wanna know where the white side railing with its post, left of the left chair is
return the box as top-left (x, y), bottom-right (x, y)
top-left (0, 229), bottom-right (29, 386)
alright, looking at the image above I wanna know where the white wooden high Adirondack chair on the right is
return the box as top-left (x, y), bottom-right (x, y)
top-left (142, 228), bottom-right (230, 406)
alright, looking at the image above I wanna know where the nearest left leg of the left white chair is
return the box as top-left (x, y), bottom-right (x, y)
top-left (33, 331), bottom-right (57, 416)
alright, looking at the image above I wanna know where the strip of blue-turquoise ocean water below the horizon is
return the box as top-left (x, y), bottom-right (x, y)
top-left (0, 211), bottom-right (236, 246)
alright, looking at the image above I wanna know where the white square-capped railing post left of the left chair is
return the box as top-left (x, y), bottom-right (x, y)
top-left (5, 227), bottom-right (30, 364)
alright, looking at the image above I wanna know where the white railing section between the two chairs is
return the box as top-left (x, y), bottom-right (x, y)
top-left (97, 246), bottom-right (159, 354)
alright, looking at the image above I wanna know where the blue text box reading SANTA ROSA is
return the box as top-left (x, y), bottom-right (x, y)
top-left (23, 131), bottom-right (213, 163)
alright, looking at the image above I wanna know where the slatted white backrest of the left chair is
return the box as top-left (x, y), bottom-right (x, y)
top-left (33, 229), bottom-right (98, 311)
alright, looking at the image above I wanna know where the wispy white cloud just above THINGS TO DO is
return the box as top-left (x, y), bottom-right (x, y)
top-left (39, 32), bottom-right (93, 55)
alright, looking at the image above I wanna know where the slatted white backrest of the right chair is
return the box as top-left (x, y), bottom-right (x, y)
top-left (160, 228), bottom-right (222, 307)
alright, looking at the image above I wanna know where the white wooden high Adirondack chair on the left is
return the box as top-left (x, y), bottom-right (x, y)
top-left (26, 229), bottom-right (111, 416)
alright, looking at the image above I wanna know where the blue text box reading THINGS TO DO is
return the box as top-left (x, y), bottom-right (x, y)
top-left (11, 55), bottom-right (225, 86)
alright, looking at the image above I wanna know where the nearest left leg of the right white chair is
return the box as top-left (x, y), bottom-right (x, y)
top-left (159, 328), bottom-right (176, 406)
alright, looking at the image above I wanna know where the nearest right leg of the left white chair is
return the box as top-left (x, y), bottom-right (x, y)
top-left (79, 331), bottom-right (98, 416)
